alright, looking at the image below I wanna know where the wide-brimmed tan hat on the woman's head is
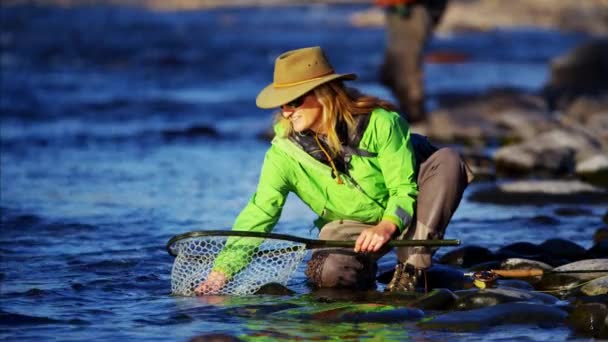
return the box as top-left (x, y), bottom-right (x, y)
top-left (255, 46), bottom-right (357, 108)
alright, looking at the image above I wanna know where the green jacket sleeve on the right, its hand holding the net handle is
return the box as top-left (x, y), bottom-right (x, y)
top-left (374, 112), bottom-right (418, 231)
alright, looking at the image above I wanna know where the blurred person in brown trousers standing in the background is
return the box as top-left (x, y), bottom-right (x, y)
top-left (375, 0), bottom-right (447, 123)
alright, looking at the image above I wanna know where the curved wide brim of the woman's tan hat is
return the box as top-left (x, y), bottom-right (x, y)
top-left (255, 74), bottom-right (357, 109)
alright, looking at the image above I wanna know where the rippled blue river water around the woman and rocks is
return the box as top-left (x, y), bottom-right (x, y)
top-left (0, 5), bottom-right (604, 341)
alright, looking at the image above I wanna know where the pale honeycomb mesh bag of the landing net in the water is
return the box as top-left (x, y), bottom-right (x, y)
top-left (169, 236), bottom-right (306, 296)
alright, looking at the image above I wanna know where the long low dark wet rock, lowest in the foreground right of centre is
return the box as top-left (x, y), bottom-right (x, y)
top-left (418, 303), bottom-right (568, 331)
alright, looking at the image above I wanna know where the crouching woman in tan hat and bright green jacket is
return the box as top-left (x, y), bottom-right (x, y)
top-left (195, 47), bottom-right (471, 294)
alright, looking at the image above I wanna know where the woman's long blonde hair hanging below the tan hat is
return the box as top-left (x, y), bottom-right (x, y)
top-left (276, 80), bottom-right (396, 157)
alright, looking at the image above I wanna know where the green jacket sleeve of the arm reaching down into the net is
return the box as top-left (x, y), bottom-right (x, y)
top-left (213, 147), bottom-right (289, 278)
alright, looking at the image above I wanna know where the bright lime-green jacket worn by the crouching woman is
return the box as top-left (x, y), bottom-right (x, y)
top-left (215, 108), bottom-right (418, 275)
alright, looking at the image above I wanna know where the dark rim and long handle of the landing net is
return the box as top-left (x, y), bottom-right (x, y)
top-left (166, 230), bottom-right (460, 256)
